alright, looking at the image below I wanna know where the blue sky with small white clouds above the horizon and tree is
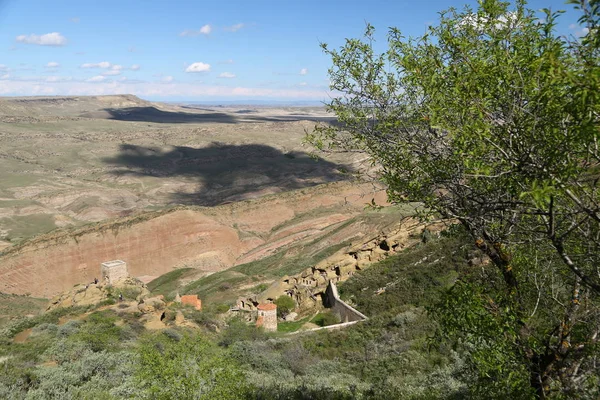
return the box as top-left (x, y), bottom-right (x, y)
top-left (0, 0), bottom-right (592, 101)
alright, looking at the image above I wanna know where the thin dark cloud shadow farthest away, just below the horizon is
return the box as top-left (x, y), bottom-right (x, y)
top-left (103, 106), bottom-right (335, 124)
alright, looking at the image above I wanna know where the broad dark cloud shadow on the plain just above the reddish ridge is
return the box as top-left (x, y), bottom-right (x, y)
top-left (103, 143), bottom-right (350, 206)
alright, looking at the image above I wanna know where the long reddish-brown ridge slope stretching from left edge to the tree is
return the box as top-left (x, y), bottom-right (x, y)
top-left (0, 184), bottom-right (385, 297)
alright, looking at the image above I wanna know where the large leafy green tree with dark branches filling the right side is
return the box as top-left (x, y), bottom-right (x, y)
top-left (308, 0), bottom-right (600, 398)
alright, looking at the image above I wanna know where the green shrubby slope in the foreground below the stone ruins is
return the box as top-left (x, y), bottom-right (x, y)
top-left (0, 235), bottom-right (473, 399)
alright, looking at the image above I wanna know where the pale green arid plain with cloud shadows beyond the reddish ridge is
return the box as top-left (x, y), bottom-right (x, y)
top-left (0, 95), bottom-right (361, 249)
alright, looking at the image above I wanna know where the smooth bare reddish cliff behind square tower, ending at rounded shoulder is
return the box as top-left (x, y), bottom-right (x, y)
top-left (0, 210), bottom-right (245, 297)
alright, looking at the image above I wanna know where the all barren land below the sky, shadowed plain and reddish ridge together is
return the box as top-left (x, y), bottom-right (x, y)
top-left (0, 95), bottom-right (404, 298)
